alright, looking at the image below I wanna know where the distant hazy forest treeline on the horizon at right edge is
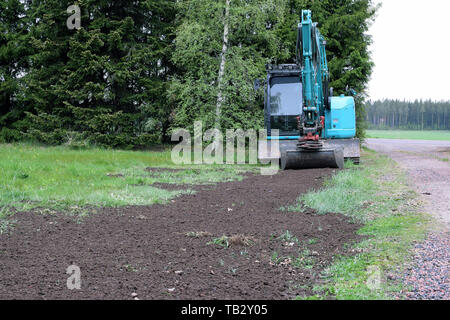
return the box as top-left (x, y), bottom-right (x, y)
top-left (366, 100), bottom-right (450, 130)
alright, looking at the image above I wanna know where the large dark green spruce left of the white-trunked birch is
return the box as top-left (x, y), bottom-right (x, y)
top-left (23, 0), bottom-right (175, 147)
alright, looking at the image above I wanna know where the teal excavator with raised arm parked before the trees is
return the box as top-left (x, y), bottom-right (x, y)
top-left (256, 10), bottom-right (360, 170)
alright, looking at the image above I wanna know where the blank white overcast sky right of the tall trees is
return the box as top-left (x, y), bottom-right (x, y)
top-left (369, 0), bottom-right (450, 100)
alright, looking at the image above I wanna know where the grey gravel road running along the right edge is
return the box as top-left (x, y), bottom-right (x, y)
top-left (366, 139), bottom-right (450, 300)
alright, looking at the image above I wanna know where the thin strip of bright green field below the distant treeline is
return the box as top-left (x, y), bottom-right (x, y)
top-left (367, 130), bottom-right (450, 141)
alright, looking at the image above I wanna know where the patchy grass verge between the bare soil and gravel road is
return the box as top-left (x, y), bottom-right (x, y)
top-left (288, 149), bottom-right (432, 300)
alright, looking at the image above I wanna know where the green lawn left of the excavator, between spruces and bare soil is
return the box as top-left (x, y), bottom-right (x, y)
top-left (0, 144), bottom-right (250, 215)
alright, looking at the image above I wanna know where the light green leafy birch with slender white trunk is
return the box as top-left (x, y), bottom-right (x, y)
top-left (170, 0), bottom-right (286, 130)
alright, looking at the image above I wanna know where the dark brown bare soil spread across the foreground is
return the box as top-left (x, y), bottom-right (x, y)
top-left (0, 169), bottom-right (360, 299)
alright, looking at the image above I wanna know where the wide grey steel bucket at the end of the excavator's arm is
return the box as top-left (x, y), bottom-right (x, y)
top-left (280, 147), bottom-right (344, 170)
